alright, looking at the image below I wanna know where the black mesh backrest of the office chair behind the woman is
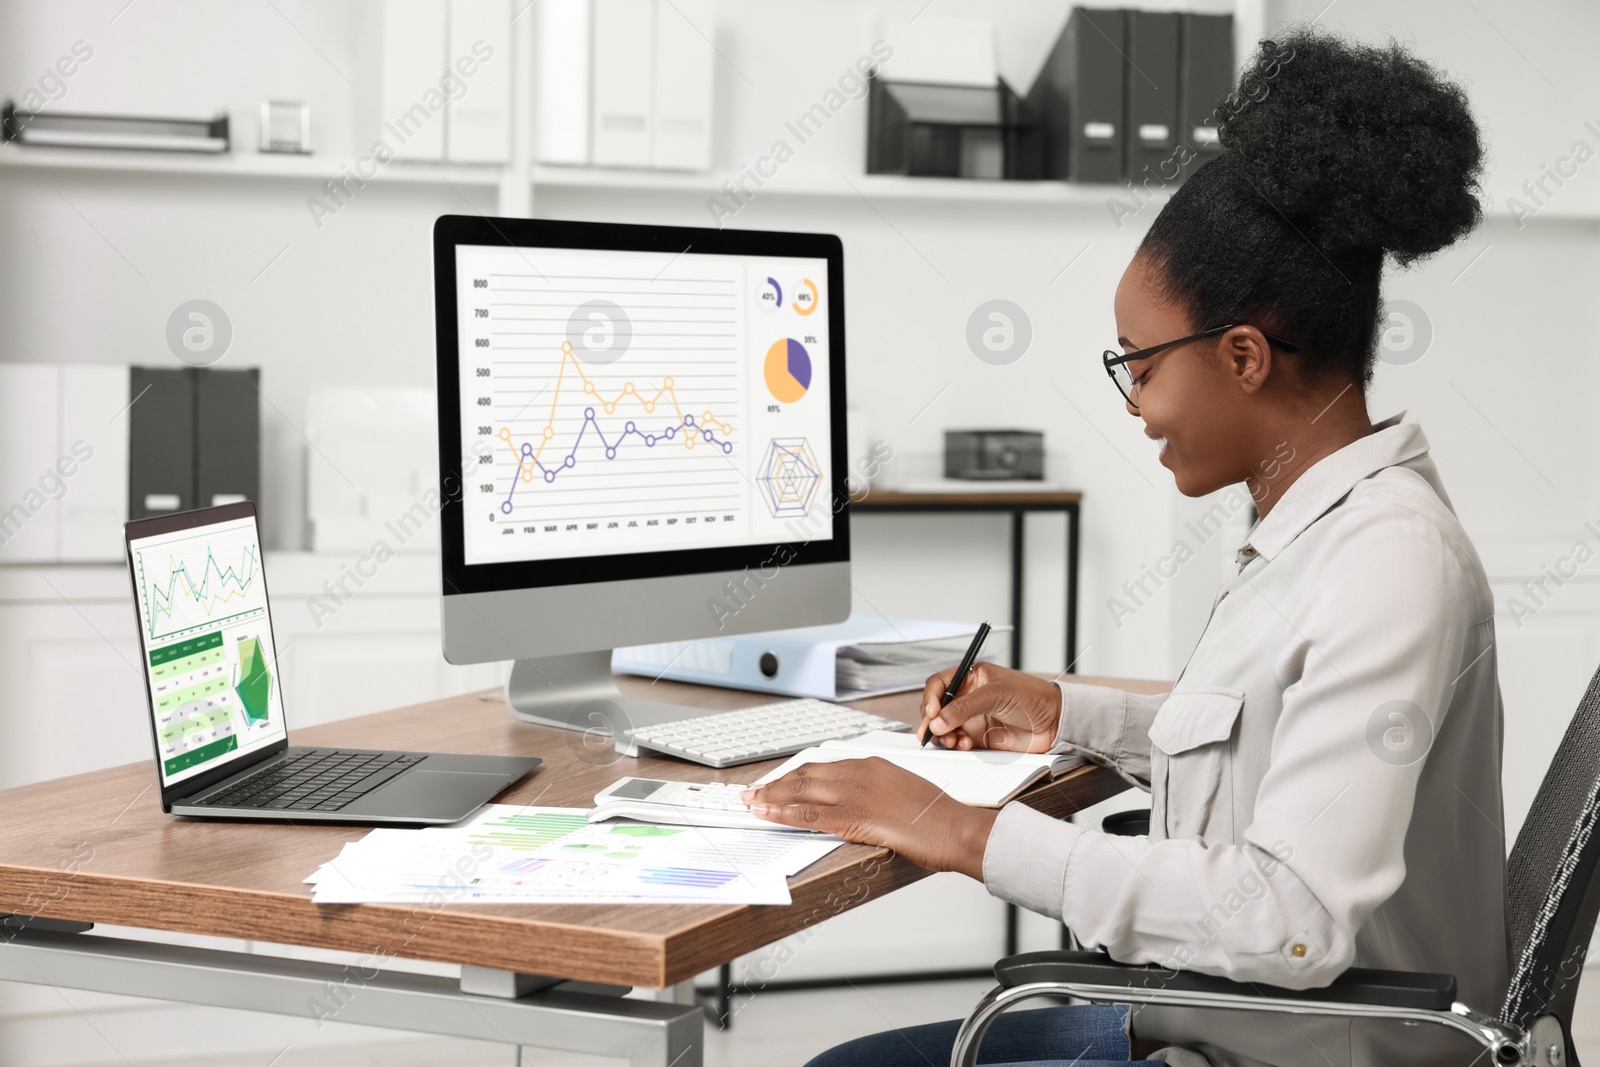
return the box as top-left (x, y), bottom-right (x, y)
top-left (1497, 672), bottom-right (1600, 1036)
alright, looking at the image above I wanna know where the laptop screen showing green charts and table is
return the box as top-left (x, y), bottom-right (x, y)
top-left (128, 517), bottom-right (286, 787)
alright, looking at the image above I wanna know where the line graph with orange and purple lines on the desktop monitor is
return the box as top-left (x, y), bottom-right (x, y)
top-left (462, 262), bottom-right (750, 552)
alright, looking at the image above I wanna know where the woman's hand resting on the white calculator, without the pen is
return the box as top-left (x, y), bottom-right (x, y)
top-left (744, 757), bottom-right (998, 881)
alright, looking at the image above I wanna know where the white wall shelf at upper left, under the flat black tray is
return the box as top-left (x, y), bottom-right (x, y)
top-left (0, 144), bottom-right (502, 187)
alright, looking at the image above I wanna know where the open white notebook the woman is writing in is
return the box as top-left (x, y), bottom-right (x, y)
top-left (755, 729), bottom-right (1083, 808)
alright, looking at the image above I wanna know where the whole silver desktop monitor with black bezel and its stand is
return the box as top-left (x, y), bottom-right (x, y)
top-left (434, 216), bottom-right (851, 728)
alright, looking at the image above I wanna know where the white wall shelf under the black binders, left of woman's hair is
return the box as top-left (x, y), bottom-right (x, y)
top-left (531, 165), bottom-right (1171, 210)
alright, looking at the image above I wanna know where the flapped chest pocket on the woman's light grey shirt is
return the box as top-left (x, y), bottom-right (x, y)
top-left (1150, 688), bottom-right (1245, 843)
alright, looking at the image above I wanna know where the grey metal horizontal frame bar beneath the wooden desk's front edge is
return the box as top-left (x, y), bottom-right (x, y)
top-left (0, 928), bottom-right (706, 1067)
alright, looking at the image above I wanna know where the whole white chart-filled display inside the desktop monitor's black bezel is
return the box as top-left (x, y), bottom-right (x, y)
top-left (454, 243), bottom-right (835, 566)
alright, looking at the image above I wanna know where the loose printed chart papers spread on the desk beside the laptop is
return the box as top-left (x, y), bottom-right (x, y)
top-left (306, 805), bottom-right (843, 905)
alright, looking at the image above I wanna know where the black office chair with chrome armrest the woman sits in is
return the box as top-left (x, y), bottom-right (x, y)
top-left (950, 672), bottom-right (1600, 1067)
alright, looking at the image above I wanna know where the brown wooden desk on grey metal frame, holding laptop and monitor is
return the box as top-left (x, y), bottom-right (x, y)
top-left (0, 678), bottom-right (1165, 1067)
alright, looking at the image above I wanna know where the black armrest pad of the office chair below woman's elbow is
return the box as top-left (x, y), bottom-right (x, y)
top-left (995, 952), bottom-right (1456, 1011)
